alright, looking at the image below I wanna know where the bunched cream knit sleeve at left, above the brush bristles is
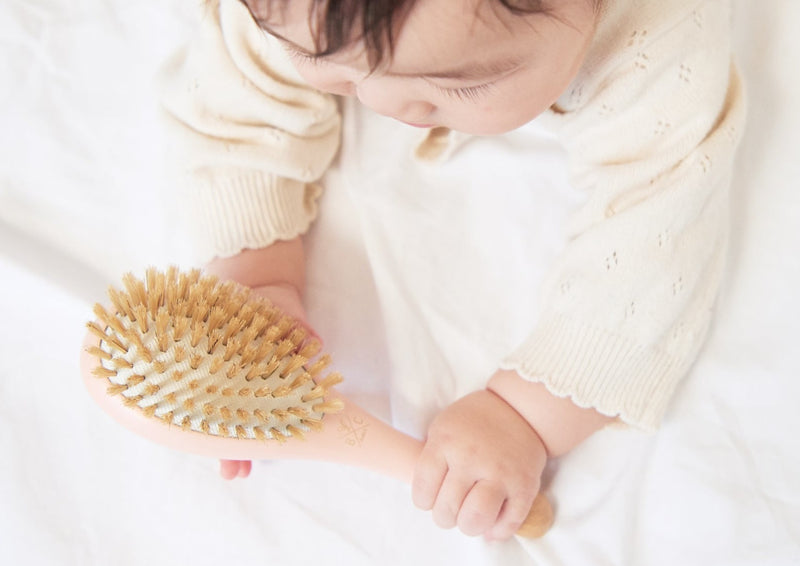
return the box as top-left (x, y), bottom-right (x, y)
top-left (160, 0), bottom-right (340, 261)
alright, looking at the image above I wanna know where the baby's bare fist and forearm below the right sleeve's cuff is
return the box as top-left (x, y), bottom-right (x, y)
top-left (412, 370), bottom-right (612, 540)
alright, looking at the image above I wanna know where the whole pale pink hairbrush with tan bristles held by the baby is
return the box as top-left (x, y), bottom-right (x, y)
top-left (81, 268), bottom-right (553, 538)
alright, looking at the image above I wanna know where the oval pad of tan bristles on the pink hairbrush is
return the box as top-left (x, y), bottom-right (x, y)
top-left (87, 268), bottom-right (342, 441)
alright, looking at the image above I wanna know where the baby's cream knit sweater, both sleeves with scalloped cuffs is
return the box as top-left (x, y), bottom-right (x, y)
top-left (163, 0), bottom-right (744, 429)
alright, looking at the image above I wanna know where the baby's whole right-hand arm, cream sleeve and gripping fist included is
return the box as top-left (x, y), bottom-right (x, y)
top-left (414, 2), bottom-right (744, 537)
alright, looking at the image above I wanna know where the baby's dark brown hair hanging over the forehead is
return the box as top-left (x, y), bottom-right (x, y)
top-left (242, 0), bottom-right (546, 68)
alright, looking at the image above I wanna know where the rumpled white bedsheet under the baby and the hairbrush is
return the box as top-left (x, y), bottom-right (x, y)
top-left (0, 0), bottom-right (800, 566)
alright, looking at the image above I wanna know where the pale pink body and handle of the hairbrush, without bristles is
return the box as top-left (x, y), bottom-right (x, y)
top-left (81, 335), bottom-right (553, 538)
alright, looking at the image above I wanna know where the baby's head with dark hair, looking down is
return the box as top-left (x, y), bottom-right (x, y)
top-left (242, 0), bottom-right (601, 134)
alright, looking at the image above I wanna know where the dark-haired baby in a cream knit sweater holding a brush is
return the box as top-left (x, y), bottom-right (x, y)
top-left (156, 0), bottom-right (743, 540)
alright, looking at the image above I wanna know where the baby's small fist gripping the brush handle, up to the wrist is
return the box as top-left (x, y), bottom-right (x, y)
top-left (412, 390), bottom-right (547, 540)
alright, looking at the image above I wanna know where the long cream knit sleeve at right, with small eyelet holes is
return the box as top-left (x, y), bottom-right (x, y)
top-left (502, 0), bottom-right (744, 430)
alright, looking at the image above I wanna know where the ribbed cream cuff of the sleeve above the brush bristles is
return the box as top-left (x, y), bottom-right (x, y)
top-left (189, 171), bottom-right (322, 261)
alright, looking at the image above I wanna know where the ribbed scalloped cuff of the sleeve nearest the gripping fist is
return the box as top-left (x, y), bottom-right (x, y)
top-left (501, 316), bottom-right (687, 431)
